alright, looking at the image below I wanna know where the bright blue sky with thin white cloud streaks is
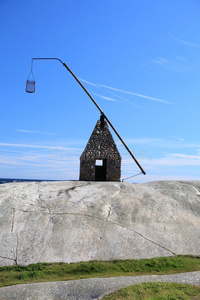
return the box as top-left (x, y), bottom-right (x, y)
top-left (0, 0), bottom-right (200, 182)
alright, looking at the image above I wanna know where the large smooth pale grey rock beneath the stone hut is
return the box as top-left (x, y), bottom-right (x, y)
top-left (0, 181), bottom-right (200, 266)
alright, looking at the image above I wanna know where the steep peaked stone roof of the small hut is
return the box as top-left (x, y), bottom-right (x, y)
top-left (80, 120), bottom-right (121, 160)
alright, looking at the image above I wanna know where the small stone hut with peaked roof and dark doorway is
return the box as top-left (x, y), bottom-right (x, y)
top-left (79, 115), bottom-right (121, 181)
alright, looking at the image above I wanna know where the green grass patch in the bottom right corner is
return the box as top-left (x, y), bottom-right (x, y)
top-left (103, 282), bottom-right (200, 300)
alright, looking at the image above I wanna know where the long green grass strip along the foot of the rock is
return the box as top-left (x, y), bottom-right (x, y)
top-left (0, 255), bottom-right (200, 287)
